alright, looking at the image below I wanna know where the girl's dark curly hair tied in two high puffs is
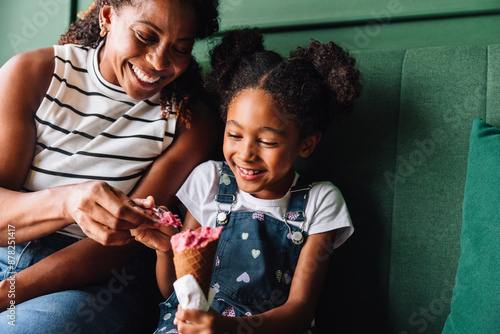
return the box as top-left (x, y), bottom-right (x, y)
top-left (205, 28), bottom-right (361, 137)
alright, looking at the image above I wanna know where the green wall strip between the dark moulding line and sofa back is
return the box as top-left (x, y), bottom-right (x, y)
top-left (194, 14), bottom-right (500, 67)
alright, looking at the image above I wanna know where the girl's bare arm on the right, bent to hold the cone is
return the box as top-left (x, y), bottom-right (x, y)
top-left (175, 231), bottom-right (336, 334)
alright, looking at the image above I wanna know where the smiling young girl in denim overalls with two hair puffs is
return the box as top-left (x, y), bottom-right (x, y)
top-left (131, 29), bottom-right (361, 333)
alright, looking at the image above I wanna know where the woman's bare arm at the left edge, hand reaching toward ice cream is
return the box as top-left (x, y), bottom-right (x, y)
top-left (0, 48), bottom-right (150, 246)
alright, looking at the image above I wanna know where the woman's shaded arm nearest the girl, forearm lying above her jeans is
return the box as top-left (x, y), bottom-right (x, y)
top-left (0, 71), bottom-right (218, 306)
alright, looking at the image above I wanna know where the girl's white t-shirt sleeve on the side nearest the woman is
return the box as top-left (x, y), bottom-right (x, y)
top-left (176, 161), bottom-right (218, 226)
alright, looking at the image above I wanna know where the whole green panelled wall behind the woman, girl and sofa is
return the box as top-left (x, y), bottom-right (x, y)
top-left (0, 0), bottom-right (500, 64)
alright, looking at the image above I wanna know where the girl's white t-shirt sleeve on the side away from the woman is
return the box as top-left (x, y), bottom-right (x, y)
top-left (306, 182), bottom-right (354, 248)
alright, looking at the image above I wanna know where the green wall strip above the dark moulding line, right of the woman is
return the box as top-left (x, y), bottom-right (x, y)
top-left (220, 0), bottom-right (500, 29)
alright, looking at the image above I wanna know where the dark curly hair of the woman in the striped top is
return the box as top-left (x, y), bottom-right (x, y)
top-left (58, 0), bottom-right (219, 127)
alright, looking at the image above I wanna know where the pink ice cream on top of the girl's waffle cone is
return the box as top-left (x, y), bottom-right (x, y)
top-left (170, 226), bottom-right (222, 253)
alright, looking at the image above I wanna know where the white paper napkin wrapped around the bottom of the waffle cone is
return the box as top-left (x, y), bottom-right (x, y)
top-left (174, 274), bottom-right (216, 312)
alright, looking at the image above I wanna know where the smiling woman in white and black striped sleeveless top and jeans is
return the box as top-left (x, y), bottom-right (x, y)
top-left (0, 0), bottom-right (218, 333)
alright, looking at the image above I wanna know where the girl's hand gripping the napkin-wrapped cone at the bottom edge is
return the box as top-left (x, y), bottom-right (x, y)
top-left (174, 305), bottom-right (223, 334)
